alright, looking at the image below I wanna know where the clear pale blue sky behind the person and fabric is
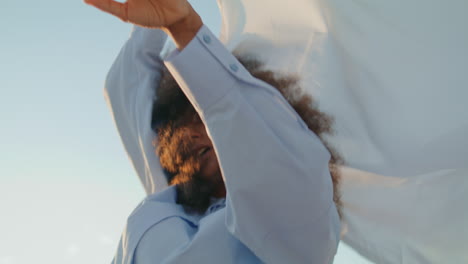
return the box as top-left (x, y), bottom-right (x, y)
top-left (0, 0), bottom-right (369, 264)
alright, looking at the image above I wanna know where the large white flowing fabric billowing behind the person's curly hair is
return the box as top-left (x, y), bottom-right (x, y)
top-left (214, 0), bottom-right (468, 263)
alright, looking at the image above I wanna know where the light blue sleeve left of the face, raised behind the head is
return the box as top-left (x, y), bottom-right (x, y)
top-left (104, 26), bottom-right (167, 194)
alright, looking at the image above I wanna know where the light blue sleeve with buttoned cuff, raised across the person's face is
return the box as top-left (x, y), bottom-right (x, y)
top-left (165, 27), bottom-right (340, 263)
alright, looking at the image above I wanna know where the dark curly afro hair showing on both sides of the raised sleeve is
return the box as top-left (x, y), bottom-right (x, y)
top-left (151, 56), bottom-right (343, 217)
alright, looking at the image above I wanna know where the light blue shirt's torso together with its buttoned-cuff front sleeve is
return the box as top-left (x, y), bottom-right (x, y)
top-left (107, 27), bottom-right (340, 264)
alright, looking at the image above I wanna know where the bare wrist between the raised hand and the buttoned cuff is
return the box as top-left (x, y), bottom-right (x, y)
top-left (163, 9), bottom-right (203, 50)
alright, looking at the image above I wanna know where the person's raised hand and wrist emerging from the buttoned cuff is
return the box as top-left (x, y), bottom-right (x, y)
top-left (84, 0), bottom-right (203, 49)
